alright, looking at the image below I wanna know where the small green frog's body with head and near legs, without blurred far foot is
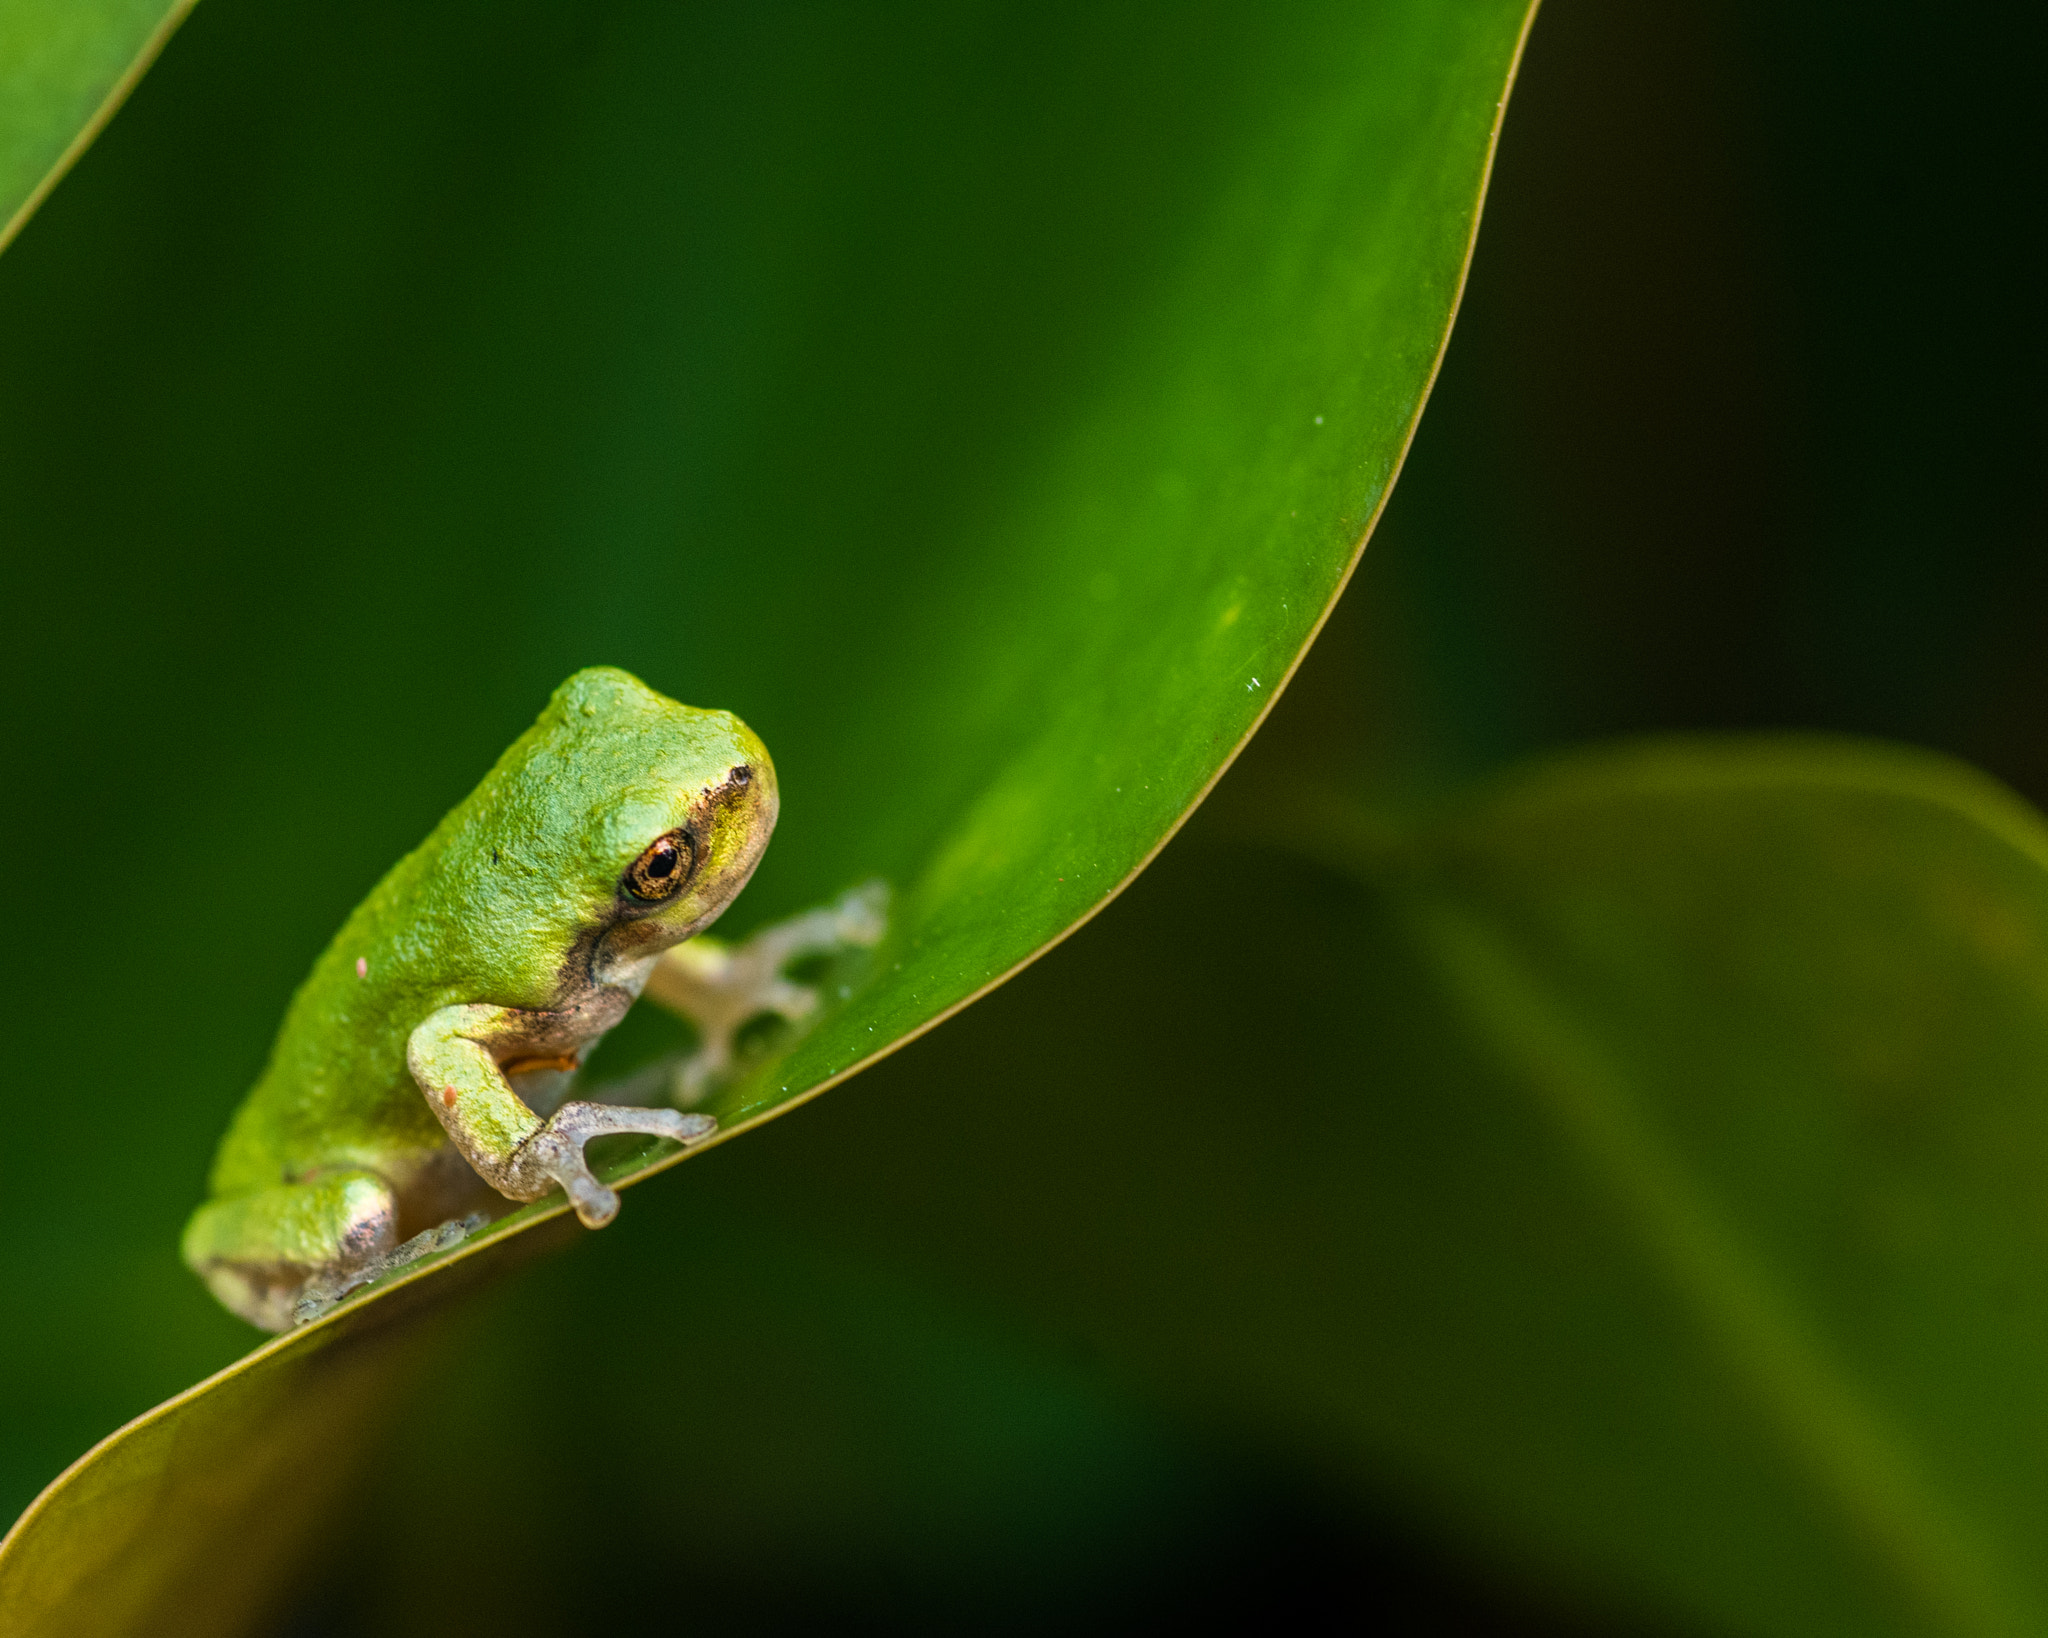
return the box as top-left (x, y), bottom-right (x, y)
top-left (184, 667), bottom-right (776, 1329)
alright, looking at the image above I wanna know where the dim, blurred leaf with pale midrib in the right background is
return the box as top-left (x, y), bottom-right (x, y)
top-left (700, 739), bottom-right (2048, 1634)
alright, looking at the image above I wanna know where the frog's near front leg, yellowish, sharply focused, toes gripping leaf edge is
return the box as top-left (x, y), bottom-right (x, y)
top-left (406, 1005), bottom-right (719, 1229)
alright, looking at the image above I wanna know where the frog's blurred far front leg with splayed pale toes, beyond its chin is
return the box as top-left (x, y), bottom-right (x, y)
top-left (645, 880), bottom-right (889, 1108)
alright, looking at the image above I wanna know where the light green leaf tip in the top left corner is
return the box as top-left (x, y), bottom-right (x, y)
top-left (0, 0), bottom-right (193, 250)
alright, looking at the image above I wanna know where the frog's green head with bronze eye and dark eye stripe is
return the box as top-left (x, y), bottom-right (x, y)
top-left (530, 665), bottom-right (778, 983)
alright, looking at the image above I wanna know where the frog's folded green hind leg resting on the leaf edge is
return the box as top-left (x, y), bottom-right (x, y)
top-left (182, 1171), bottom-right (397, 1331)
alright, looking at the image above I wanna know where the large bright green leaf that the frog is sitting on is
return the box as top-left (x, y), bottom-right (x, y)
top-left (0, 0), bottom-right (1526, 1620)
